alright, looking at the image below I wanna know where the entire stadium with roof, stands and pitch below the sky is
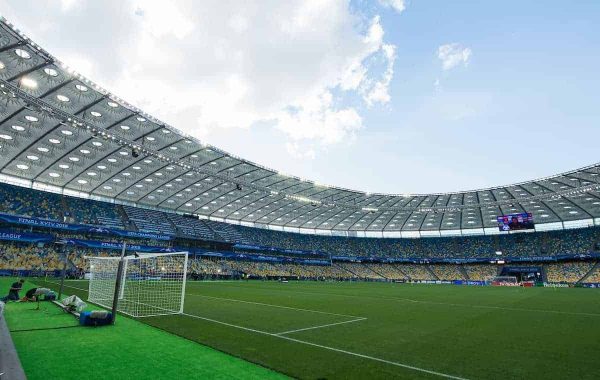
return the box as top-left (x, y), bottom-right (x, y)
top-left (0, 5), bottom-right (600, 379)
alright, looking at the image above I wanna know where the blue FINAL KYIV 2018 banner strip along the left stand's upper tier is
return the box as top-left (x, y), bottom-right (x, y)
top-left (0, 213), bottom-right (172, 240)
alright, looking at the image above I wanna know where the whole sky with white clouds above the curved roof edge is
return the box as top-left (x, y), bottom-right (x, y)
top-left (0, 0), bottom-right (600, 194)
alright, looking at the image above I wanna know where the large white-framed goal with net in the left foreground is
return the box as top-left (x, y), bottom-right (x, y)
top-left (86, 252), bottom-right (188, 317)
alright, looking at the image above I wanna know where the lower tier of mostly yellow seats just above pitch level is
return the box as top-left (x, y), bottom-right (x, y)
top-left (0, 241), bottom-right (600, 284)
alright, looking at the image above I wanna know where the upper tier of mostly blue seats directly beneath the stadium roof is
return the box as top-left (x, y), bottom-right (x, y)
top-left (0, 184), bottom-right (600, 264)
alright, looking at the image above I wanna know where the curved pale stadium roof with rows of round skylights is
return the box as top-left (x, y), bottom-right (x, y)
top-left (0, 18), bottom-right (600, 235)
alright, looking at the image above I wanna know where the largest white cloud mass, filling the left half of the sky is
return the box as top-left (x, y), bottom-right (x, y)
top-left (2, 0), bottom-right (401, 158)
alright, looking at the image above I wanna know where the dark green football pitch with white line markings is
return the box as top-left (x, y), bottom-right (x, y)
top-left (21, 280), bottom-right (600, 379)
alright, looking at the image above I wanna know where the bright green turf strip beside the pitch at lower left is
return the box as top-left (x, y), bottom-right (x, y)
top-left (0, 279), bottom-right (283, 380)
